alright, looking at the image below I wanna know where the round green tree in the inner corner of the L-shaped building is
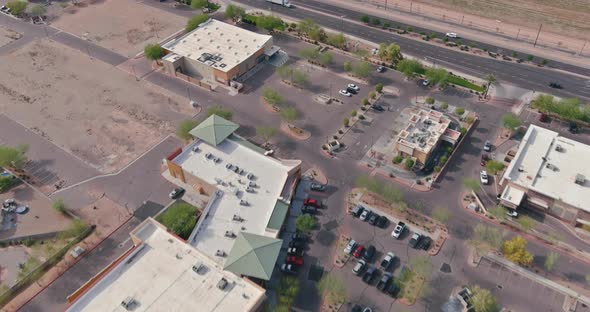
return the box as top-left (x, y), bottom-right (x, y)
top-left (156, 203), bottom-right (197, 240)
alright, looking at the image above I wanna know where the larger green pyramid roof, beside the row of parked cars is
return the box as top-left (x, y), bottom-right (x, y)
top-left (223, 232), bottom-right (283, 281)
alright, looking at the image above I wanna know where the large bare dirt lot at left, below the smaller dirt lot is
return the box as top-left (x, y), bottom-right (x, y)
top-left (0, 39), bottom-right (188, 172)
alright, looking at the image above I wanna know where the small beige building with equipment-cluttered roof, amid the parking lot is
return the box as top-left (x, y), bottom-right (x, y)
top-left (394, 109), bottom-right (461, 165)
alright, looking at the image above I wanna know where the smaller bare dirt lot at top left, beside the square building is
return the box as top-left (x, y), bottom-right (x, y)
top-left (51, 0), bottom-right (186, 57)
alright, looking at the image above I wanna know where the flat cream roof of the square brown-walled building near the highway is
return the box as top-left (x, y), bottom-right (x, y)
top-left (162, 19), bottom-right (272, 72)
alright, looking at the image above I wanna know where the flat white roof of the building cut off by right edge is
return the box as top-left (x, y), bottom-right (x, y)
top-left (504, 125), bottom-right (590, 212)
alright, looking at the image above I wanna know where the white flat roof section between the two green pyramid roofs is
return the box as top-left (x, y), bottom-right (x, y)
top-left (173, 139), bottom-right (300, 263)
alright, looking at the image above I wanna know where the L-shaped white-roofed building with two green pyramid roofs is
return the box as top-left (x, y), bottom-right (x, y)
top-left (166, 115), bottom-right (301, 280)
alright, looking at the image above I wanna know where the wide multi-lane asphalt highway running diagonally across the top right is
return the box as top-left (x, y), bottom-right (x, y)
top-left (236, 0), bottom-right (590, 99)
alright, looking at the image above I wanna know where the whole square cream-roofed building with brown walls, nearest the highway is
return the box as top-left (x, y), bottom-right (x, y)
top-left (162, 19), bottom-right (279, 85)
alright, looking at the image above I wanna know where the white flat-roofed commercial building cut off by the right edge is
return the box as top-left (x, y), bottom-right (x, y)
top-left (500, 125), bottom-right (590, 224)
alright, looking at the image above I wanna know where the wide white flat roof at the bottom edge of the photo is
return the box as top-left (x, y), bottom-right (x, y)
top-left (68, 218), bottom-right (265, 312)
